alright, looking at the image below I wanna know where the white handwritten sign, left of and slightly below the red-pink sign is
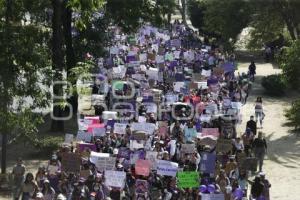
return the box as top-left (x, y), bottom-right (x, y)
top-left (105, 170), bottom-right (126, 189)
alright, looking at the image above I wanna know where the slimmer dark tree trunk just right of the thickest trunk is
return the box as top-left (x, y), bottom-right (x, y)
top-left (63, 2), bottom-right (78, 115)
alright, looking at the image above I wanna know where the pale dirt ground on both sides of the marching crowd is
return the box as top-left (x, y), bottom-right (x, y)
top-left (0, 63), bottom-right (300, 200)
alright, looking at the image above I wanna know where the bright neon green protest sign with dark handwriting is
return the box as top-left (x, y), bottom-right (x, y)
top-left (177, 171), bottom-right (199, 189)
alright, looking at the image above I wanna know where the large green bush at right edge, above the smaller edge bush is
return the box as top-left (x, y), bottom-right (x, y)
top-left (278, 40), bottom-right (300, 89)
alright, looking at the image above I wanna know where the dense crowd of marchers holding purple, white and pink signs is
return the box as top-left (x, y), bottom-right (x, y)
top-left (12, 20), bottom-right (271, 200)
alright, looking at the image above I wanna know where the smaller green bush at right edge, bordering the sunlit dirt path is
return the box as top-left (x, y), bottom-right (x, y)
top-left (285, 99), bottom-right (300, 129)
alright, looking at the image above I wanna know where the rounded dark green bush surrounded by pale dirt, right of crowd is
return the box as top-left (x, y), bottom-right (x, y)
top-left (261, 74), bottom-right (287, 96)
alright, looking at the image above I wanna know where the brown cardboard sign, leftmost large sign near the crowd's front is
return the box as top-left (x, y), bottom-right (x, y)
top-left (61, 153), bottom-right (81, 173)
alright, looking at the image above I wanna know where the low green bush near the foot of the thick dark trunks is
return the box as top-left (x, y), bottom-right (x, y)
top-left (35, 136), bottom-right (64, 154)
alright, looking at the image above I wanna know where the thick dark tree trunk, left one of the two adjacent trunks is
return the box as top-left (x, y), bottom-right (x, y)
top-left (51, 0), bottom-right (64, 132)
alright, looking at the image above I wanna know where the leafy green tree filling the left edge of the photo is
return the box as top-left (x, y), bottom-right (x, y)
top-left (0, 0), bottom-right (51, 173)
